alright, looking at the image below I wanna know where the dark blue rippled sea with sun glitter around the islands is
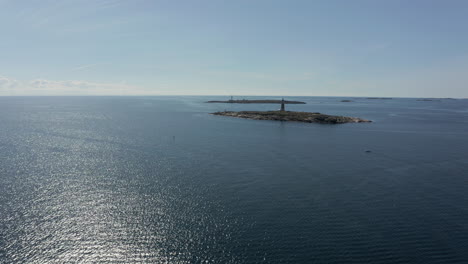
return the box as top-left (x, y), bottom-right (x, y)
top-left (0, 96), bottom-right (468, 264)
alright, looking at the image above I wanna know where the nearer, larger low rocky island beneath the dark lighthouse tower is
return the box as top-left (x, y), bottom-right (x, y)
top-left (212, 111), bottom-right (372, 124)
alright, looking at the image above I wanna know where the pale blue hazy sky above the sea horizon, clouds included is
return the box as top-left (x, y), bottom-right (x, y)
top-left (0, 0), bottom-right (468, 98)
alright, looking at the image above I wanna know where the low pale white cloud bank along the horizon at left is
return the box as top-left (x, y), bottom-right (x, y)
top-left (0, 76), bottom-right (157, 95)
